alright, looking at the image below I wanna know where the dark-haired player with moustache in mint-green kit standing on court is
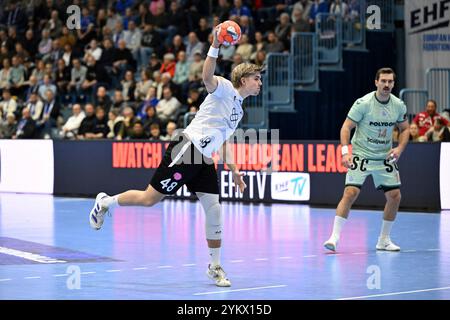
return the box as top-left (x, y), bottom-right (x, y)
top-left (324, 68), bottom-right (409, 251)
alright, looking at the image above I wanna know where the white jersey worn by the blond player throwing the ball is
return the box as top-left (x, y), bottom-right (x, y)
top-left (183, 77), bottom-right (244, 158)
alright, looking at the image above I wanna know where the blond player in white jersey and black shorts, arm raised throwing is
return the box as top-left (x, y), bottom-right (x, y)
top-left (89, 24), bottom-right (262, 287)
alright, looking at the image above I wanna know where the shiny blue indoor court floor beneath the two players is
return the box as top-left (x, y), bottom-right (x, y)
top-left (0, 194), bottom-right (450, 300)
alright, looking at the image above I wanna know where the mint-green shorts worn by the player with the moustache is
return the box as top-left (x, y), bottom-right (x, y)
top-left (345, 155), bottom-right (401, 192)
